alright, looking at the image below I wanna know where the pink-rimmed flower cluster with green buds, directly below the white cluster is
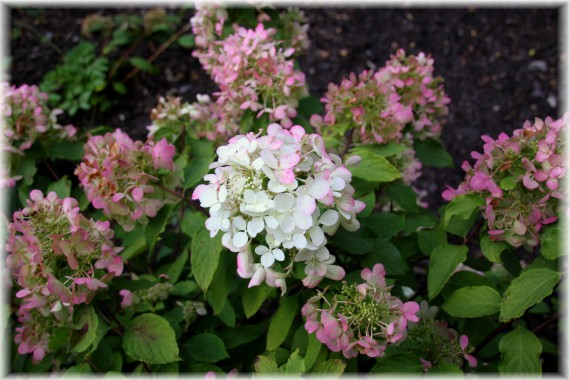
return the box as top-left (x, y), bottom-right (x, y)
top-left (301, 264), bottom-right (420, 359)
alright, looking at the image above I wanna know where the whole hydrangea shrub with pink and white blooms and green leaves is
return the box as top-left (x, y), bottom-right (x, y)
top-left (5, 4), bottom-right (568, 378)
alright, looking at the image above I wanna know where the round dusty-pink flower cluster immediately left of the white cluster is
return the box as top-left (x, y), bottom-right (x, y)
top-left (75, 129), bottom-right (180, 231)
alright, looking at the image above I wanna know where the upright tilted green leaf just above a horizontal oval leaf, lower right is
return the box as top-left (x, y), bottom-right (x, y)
top-left (428, 244), bottom-right (468, 299)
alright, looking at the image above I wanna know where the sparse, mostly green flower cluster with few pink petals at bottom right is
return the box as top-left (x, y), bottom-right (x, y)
top-left (406, 301), bottom-right (477, 371)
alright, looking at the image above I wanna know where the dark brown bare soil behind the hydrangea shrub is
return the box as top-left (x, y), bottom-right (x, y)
top-left (8, 3), bottom-right (564, 371)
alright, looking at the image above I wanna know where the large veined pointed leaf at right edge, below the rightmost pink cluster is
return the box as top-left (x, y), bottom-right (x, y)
top-left (499, 268), bottom-right (560, 322)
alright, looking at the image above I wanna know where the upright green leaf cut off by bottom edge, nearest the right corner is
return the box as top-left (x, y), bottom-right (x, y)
top-left (499, 326), bottom-right (542, 375)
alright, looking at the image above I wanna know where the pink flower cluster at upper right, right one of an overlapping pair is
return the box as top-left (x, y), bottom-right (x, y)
top-left (378, 49), bottom-right (450, 140)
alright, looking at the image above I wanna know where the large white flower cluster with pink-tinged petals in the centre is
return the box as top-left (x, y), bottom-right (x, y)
top-left (192, 124), bottom-right (364, 292)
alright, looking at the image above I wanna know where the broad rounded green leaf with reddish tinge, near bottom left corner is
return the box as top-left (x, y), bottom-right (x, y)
top-left (123, 313), bottom-right (179, 364)
